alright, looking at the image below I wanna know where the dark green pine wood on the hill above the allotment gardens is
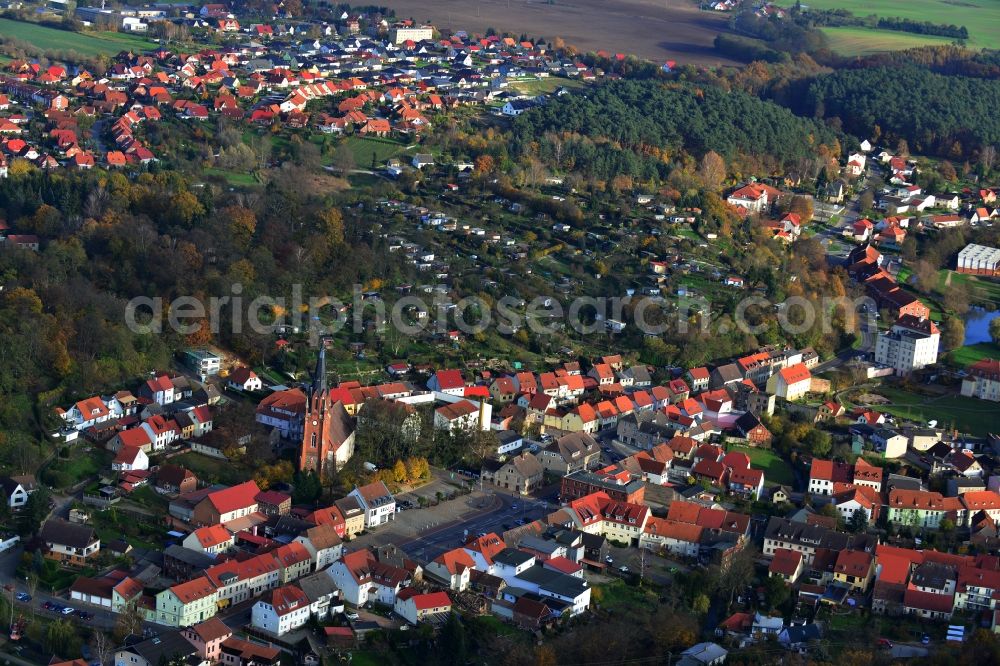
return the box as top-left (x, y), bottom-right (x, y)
top-left (511, 81), bottom-right (838, 180)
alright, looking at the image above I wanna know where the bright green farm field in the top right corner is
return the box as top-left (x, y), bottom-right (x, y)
top-left (803, 0), bottom-right (1000, 50)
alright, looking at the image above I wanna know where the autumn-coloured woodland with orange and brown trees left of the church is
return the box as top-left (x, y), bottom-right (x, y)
top-left (0, 166), bottom-right (395, 469)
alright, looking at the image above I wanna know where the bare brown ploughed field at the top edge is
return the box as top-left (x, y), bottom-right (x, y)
top-left (379, 0), bottom-right (737, 65)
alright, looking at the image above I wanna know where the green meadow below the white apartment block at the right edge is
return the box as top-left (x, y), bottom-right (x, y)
top-left (872, 386), bottom-right (996, 437)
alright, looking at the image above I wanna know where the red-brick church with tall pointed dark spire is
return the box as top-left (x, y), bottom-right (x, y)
top-left (299, 341), bottom-right (354, 475)
